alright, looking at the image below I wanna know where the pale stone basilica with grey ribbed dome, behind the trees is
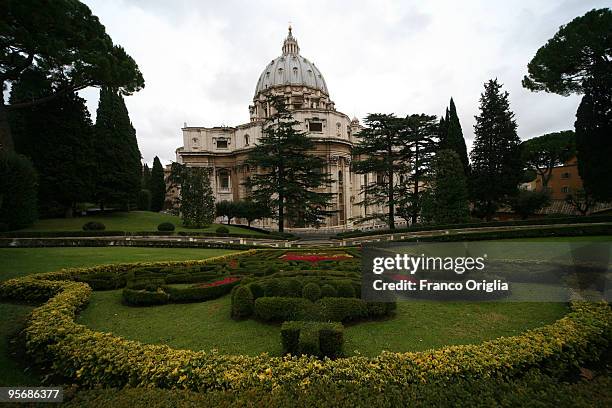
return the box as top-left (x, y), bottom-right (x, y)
top-left (176, 27), bottom-right (378, 228)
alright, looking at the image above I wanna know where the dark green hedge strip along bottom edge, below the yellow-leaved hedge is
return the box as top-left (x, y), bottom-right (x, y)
top-left (58, 371), bottom-right (612, 408)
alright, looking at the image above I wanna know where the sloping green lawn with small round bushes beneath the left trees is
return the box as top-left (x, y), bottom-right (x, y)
top-left (20, 211), bottom-right (266, 236)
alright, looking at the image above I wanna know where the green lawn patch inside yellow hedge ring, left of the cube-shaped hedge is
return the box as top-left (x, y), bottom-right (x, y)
top-left (78, 290), bottom-right (281, 355)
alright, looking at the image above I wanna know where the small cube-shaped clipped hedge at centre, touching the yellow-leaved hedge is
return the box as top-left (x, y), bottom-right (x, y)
top-left (281, 321), bottom-right (344, 358)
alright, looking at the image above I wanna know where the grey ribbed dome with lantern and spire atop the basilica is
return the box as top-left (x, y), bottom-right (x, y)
top-left (255, 27), bottom-right (329, 96)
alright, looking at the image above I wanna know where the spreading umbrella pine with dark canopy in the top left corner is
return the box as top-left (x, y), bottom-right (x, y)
top-left (0, 0), bottom-right (144, 150)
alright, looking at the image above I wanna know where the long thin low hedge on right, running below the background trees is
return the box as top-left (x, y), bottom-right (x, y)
top-left (336, 215), bottom-right (612, 239)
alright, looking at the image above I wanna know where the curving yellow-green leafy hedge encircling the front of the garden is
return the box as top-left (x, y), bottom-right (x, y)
top-left (0, 253), bottom-right (612, 391)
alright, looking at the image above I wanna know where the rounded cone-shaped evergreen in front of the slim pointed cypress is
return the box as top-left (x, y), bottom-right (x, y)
top-left (423, 150), bottom-right (469, 224)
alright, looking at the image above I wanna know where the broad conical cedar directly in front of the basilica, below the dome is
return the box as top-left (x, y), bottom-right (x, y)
top-left (245, 96), bottom-right (332, 232)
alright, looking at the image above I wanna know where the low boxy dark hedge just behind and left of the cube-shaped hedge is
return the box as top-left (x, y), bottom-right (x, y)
top-left (255, 297), bottom-right (317, 322)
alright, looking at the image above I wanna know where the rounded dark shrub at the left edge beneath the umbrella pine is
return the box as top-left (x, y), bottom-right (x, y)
top-left (0, 149), bottom-right (38, 230)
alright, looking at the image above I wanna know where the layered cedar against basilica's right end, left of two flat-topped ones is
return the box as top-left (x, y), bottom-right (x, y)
top-left (352, 113), bottom-right (407, 229)
